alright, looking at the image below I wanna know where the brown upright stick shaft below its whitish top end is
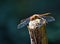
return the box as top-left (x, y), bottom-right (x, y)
top-left (28, 25), bottom-right (48, 44)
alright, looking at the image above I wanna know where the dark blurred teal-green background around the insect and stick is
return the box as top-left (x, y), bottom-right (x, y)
top-left (0, 0), bottom-right (60, 44)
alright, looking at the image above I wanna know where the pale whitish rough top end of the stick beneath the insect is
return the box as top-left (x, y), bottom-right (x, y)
top-left (29, 18), bottom-right (46, 29)
